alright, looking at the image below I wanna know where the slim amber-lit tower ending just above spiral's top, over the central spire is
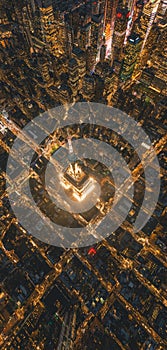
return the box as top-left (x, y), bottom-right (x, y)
top-left (68, 58), bottom-right (79, 97)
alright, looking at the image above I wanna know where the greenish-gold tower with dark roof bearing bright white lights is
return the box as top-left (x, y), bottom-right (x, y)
top-left (120, 33), bottom-right (142, 81)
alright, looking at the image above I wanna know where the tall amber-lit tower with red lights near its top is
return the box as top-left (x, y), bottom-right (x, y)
top-left (112, 7), bottom-right (129, 66)
